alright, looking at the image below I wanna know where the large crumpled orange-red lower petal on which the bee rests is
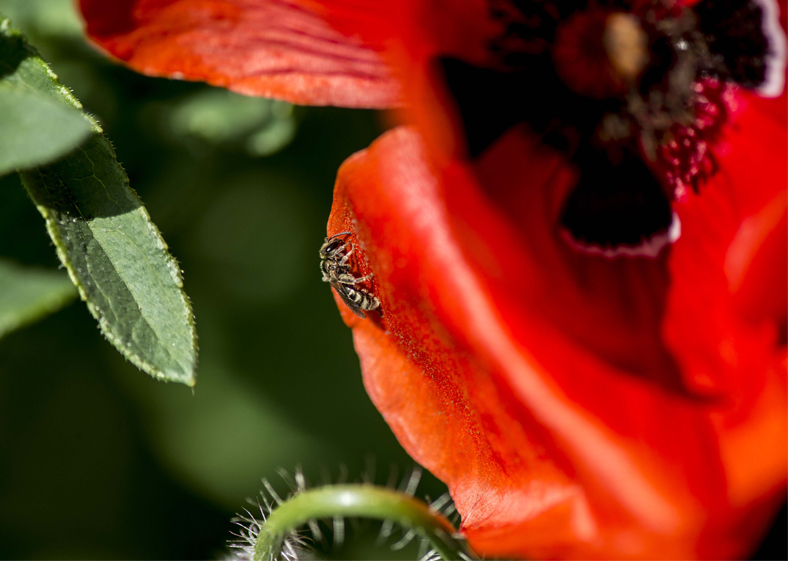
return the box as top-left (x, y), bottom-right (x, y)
top-left (329, 129), bottom-right (788, 558)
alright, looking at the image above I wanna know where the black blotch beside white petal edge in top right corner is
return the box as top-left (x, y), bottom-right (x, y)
top-left (694, 0), bottom-right (769, 88)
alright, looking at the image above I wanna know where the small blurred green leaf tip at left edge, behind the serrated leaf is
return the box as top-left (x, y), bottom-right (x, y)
top-left (0, 260), bottom-right (77, 337)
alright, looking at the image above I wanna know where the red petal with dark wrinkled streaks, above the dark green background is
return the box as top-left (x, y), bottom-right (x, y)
top-left (80, 0), bottom-right (399, 107)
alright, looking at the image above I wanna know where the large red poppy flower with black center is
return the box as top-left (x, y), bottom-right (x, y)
top-left (82, 0), bottom-right (788, 558)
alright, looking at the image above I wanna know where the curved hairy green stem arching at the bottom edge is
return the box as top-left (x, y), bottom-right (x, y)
top-left (254, 484), bottom-right (473, 561)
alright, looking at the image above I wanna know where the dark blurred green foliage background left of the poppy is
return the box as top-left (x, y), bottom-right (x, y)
top-left (0, 0), bottom-right (444, 559)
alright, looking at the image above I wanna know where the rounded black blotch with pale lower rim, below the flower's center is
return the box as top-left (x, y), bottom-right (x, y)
top-left (561, 149), bottom-right (673, 247)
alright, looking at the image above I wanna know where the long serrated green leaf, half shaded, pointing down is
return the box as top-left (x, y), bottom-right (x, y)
top-left (0, 20), bottom-right (197, 385)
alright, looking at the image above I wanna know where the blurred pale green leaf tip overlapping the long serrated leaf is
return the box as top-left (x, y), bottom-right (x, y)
top-left (0, 91), bottom-right (91, 176)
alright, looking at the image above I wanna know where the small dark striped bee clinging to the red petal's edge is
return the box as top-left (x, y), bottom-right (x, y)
top-left (320, 232), bottom-right (380, 319)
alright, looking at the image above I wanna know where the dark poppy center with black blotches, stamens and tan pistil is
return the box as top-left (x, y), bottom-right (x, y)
top-left (441, 0), bottom-right (785, 256)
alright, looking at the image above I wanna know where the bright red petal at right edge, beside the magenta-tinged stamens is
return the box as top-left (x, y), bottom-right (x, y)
top-left (664, 88), bottom-right (788, 399)
